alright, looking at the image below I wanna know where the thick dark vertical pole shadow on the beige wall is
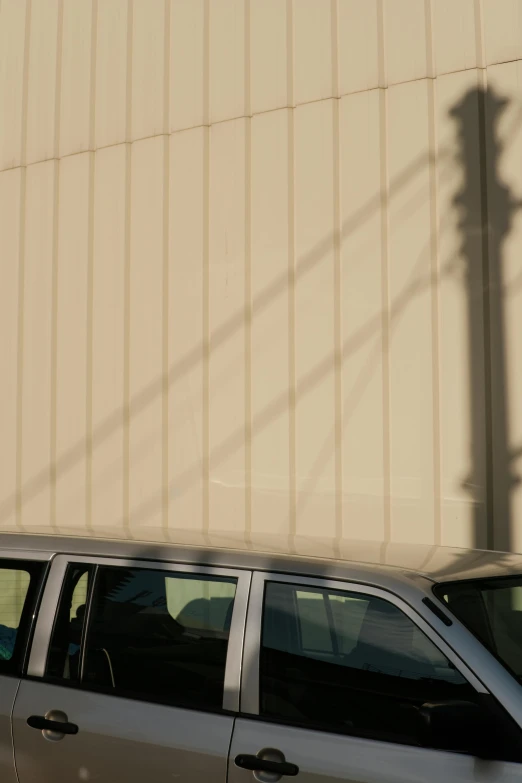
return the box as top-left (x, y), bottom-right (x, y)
top-left (450, 89), bottom-right (521, 551)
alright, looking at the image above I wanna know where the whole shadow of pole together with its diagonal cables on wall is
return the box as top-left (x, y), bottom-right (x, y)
top-left (0, 84), bottom-right (522, 550)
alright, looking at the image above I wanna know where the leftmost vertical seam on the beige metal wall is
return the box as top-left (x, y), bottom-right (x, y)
top-left (15, 0), bottom-right (32, 530)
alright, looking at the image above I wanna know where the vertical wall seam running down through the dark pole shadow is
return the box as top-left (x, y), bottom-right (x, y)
top-left (472, 69), bottom-right (495, 549)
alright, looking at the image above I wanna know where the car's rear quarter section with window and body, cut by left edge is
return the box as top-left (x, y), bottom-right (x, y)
top-left (0, 550), bottom-right (45, 783)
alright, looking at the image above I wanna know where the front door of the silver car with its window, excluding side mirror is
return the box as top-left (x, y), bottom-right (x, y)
top-left (229, 574), bottom-right (522, 783)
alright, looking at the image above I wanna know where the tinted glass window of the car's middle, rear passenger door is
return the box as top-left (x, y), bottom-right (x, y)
top-left (46, 565), bottom-right (237, 709)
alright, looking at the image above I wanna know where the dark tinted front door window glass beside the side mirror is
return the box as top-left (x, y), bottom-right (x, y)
top-left (260, 582), bottom-right (476, 744)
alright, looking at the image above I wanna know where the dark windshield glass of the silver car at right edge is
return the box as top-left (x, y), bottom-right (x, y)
top-left (435, 576), bottom-right (522, 680)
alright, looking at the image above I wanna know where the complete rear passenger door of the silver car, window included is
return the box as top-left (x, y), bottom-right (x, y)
top-left (13, 556), bottom-right (250, 783)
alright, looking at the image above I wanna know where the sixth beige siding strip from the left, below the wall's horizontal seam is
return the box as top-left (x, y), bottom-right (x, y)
top-left (166, 128), bottom-right (208, 529)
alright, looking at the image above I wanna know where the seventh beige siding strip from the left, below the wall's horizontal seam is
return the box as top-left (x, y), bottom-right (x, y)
top-left (205, 119), bottom-right (250, 530)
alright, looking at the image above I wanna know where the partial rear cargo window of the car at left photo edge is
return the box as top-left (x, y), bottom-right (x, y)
top-left (0, 559), bottom-right (43, 674)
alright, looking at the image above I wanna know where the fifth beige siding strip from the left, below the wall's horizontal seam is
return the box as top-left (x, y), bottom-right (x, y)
top-left (127, 137), bottom-right (166, 535)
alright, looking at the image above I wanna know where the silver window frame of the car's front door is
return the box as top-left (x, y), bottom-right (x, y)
top-left (240, 571), bottom-right (489, 728)
